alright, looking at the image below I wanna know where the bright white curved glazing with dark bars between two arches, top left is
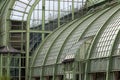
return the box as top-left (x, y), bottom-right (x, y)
top-left (10, 0), bottom-right (35, 20)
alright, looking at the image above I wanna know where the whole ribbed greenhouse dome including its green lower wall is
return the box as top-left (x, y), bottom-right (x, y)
top-left (30, 4), bottom-right (120, 80)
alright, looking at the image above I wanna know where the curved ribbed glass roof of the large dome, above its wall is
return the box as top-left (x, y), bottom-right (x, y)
top-left (32, 2), bottom-right (120, 76)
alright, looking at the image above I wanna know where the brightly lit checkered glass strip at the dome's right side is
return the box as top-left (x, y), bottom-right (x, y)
top-left (92, 15), bottom-right (120, 58)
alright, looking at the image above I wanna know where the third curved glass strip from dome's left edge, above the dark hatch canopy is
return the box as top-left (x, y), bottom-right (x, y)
top-left (59, 12), bottom-right (106, 62)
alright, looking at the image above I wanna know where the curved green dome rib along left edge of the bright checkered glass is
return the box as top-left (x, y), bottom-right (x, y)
top-left (84, 6), bottom-right (120, 80)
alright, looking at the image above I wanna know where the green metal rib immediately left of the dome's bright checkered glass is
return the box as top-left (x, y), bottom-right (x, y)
top-left (84, 4), bottom-right (120, 80)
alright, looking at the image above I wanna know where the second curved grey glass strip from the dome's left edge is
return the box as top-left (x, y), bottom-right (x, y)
top-left (46, 20), bottom-right (76, 64)
